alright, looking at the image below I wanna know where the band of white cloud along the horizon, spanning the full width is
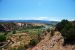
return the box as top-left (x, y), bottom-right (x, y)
top-left (0, 16), bottom-right (75, 21)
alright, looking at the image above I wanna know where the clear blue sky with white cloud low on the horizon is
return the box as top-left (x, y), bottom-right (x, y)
top-left (0, 0), bottom-right (75, 21)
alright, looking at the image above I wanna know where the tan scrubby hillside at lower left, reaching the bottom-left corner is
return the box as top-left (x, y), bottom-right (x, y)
top-left (0, 33), bottom-right (31, 50)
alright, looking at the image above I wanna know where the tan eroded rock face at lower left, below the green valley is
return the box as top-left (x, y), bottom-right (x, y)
top-left (3, 33), bottom-right (31, 50)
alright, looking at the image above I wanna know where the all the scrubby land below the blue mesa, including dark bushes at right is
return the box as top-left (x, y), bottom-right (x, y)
top-left (0, 20), bottom-right (75, 50)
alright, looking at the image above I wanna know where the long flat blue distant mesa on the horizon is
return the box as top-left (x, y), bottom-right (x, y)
top-left (0, 20), bottom-right (59, 24)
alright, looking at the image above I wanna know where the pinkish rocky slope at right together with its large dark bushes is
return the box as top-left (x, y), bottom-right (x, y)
top-left (28, 20), bottom-right (75, 50)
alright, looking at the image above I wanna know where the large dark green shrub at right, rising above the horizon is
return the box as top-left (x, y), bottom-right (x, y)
top-left (56, 20), bottom-right (75, 42)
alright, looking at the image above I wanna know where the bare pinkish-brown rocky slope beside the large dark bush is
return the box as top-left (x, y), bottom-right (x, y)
top-left (28, 31), bottom-right (75, 50)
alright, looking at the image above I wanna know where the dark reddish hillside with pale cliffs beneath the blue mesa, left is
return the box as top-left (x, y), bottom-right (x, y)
top-left (0, 22), bottom-right (46, 31)
